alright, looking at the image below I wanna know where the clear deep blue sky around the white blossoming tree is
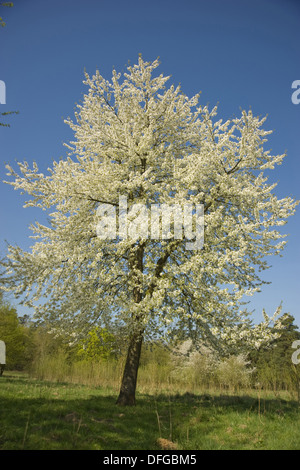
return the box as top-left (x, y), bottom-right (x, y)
top-left (0, 0), bottom-right (300, 325)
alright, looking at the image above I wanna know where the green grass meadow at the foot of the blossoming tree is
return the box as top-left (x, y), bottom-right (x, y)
top-left (0, 372), bottom-right (300, 450)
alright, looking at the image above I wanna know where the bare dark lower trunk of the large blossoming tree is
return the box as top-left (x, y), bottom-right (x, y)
top-left (117, 333), bottom-right (143, 406)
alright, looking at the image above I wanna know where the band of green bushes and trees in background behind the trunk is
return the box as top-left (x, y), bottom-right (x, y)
top-left (0, 298), bottom-right (300, 392)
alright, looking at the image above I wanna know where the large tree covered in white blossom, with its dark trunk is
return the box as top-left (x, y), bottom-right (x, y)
top-left (1, 56), bottom-right (296, 405)
